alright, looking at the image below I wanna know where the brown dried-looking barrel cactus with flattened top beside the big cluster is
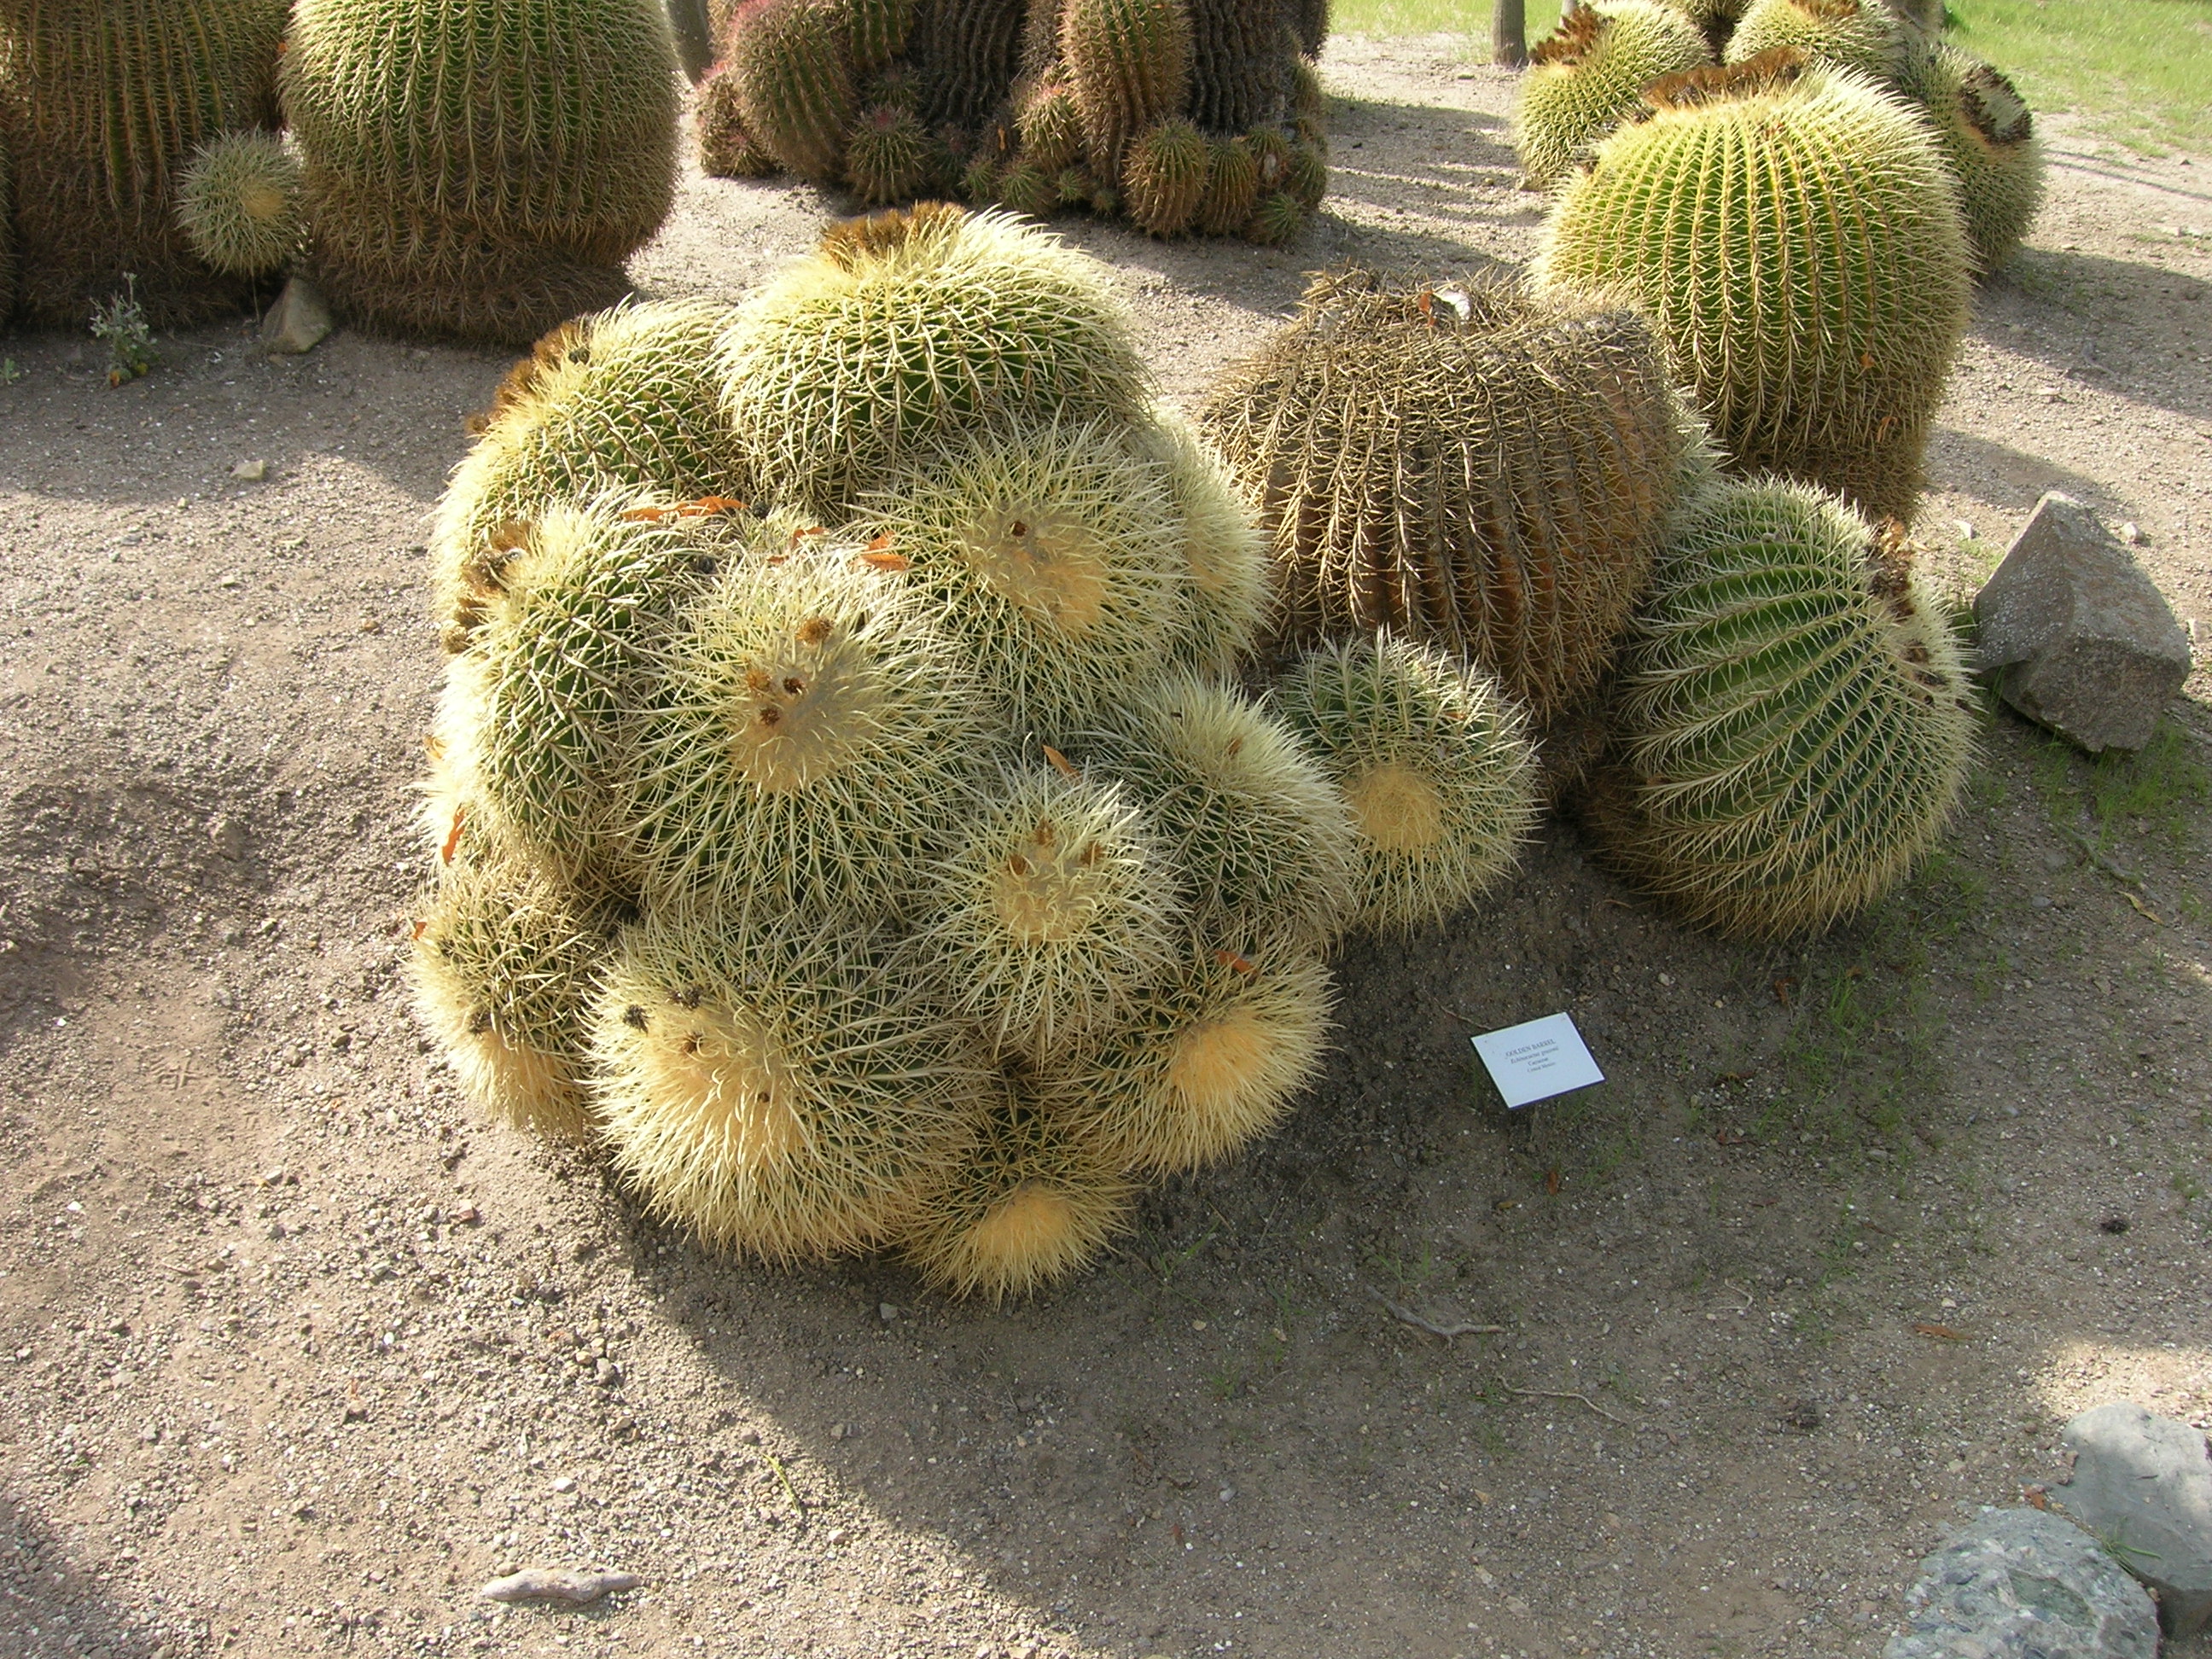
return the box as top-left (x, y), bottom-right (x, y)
top-left (1201, 270), bottom-right (1690, 717)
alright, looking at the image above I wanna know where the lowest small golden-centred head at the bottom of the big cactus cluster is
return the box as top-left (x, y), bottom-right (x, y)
top-left (900, 1084), bottom-right (1135, 1303)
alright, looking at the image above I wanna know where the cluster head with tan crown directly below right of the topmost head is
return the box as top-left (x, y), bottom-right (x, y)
top-left (854, 420), bottom-right (1190, 741)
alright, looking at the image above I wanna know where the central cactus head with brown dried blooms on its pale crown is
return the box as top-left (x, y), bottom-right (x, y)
top-left (632, 538), bottom-right (984, 923)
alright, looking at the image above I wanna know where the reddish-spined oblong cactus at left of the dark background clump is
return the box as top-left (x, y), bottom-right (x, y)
top-left (728, 0), bottom-right (860, 183)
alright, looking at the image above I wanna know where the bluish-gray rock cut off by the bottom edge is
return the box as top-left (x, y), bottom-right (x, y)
top-left (1883, 1509), bottom-right (2159, 1659)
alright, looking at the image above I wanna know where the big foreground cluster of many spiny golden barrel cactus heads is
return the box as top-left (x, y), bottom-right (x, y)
top-left (416, 206), bottom-right (1531, 1296)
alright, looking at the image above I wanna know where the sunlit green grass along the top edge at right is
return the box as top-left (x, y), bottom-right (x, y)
top-left (1331, 0), bottom-right (2212, 153)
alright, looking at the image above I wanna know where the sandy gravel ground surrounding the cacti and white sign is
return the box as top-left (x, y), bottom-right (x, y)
top-left (0, 42), bottom-right (2212, 1659)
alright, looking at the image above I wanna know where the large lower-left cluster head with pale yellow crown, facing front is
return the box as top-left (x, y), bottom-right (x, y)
top-left (588, 905), bottom-right (1000, 1263)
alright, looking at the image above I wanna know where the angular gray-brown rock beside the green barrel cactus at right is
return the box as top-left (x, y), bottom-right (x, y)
top-left (1973, 491), bottom-right (2190, 754)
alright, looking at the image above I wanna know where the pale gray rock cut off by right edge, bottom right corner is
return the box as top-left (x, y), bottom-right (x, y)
top-left (2051, 1400), bottom-right (2212, 1637)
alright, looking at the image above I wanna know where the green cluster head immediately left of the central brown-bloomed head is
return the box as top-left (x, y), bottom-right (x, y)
top-left (466, 498), bottom-right (701, 892)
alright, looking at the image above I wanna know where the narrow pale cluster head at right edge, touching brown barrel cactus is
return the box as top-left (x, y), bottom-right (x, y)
top-left (1132, 403), bottom-right (1272, 679)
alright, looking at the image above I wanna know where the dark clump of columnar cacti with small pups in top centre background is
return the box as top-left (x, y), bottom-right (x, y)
top-left (699, 0), bottom-right (1327, 243)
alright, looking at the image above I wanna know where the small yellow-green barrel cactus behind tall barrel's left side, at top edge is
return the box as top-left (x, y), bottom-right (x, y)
top-left (1513, 0), bottom-right (1710, 186)
